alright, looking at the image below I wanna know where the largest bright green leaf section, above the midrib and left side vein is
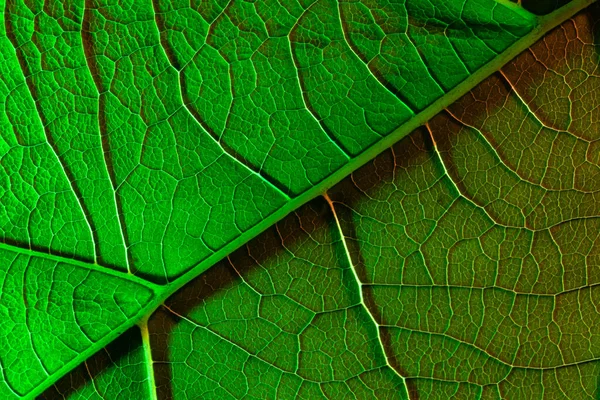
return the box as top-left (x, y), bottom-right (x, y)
top-left (0, 0), bottom-right (536, 283)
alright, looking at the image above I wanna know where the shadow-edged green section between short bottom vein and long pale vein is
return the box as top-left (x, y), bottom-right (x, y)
top-left (148, 200), bottom-right (407, 399)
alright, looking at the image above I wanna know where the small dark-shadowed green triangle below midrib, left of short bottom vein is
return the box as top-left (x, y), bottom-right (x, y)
top-left (39, 328), bottom-right (150, 400)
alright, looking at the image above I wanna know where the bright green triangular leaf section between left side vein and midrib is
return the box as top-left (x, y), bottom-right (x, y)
top-left (0, 248), bottom-right (154, 399)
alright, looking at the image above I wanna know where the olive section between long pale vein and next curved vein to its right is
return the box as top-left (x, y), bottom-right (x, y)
top-left (331, 130), bottom-right (600, 399)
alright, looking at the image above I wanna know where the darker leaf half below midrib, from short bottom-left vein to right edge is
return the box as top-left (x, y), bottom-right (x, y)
top-left (45, 6), bottom-right (600, 399)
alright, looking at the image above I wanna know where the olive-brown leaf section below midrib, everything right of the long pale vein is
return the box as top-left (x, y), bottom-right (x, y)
top-left (330, 6), bottom-right (600, 399)
